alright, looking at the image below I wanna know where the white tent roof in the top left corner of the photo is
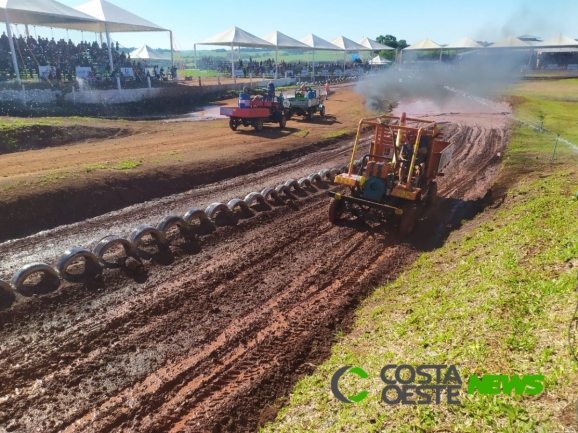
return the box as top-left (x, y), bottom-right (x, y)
top-left (0, 0), bottom-right (94, 27)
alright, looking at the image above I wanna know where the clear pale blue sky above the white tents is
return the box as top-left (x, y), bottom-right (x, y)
top-left (0, 0), bottom-right (578, 50)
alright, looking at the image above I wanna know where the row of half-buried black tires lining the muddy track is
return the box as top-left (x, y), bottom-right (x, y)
top-left (0, 161), bottom-right (359, 294)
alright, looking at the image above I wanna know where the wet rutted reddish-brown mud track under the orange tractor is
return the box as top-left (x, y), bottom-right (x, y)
top-left (0, 96), bottom-right (509, 432)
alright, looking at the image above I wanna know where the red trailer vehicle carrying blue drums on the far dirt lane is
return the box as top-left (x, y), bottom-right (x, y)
top-left (221, 99), bottom-right (286, 131)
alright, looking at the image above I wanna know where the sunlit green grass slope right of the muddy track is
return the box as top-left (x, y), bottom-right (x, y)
top-left (261, 79), bottom-right (578, 432)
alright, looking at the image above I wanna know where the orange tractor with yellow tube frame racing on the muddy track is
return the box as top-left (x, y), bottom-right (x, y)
top-left (329, 113), bottom-right (454, 235)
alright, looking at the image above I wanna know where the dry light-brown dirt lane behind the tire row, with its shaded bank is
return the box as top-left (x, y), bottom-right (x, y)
top-left (0, 86), bottom-right (367, 240)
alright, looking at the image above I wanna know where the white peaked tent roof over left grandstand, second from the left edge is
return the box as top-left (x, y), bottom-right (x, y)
top-left (68, 0), bottom-right (167, 33)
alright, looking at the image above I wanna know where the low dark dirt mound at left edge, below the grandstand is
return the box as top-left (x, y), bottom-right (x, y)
top-left (0, 124), bottom-right (130, 155)
